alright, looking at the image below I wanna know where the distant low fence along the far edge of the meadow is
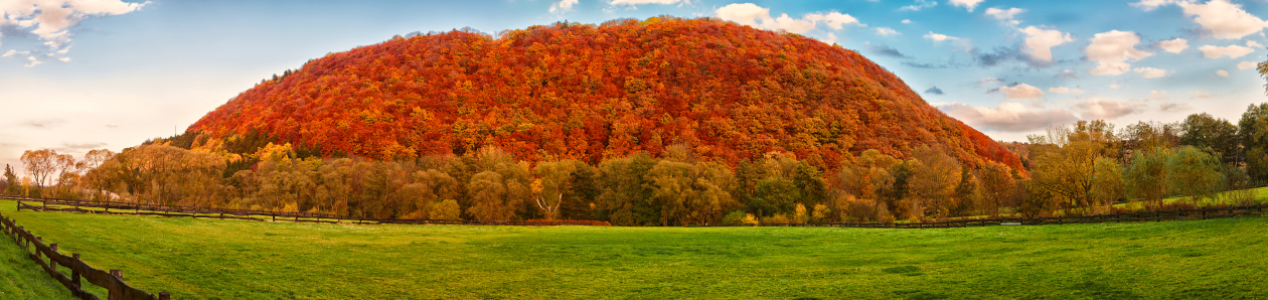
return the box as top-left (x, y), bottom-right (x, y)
top-left (5, 196), bottom-right (1268, 229)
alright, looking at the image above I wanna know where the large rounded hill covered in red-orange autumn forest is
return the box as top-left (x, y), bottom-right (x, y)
top-left (183, 18), bottom-right (1021, 170)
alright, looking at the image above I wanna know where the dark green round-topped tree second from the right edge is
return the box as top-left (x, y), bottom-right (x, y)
top-left (1181, 113), bottom-right (1238, 163)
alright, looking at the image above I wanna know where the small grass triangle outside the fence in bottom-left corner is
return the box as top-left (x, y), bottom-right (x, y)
top-left (0, 221), bottom-right (75, 299)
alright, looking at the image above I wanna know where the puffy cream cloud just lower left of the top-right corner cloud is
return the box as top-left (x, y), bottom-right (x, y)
top-left (1083, 30), bottom-right (1153, 75)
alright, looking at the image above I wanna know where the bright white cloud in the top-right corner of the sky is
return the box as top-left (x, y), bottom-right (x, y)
top-left (1175, 0), bottom-right (1265, 39)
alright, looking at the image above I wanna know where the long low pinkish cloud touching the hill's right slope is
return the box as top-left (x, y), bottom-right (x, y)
top-left (936, 103), bottom-right (1077, 132)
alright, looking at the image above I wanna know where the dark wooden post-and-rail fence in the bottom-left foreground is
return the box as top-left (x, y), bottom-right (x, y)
top-left (0, 210), bottom-right (171, 300)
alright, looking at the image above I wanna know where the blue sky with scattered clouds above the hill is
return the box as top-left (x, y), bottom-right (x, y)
top-left (0, 0), bottom-right (1268, 173)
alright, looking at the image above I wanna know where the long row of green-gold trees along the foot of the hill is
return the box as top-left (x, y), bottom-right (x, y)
top-left (7, 104), bottom-right (1268, 225)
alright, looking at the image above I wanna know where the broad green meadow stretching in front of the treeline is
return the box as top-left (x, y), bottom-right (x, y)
top-left (0, 201), bottom-right (1268, 299)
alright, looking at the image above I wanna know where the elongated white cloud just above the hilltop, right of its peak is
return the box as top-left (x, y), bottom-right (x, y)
top-left (714, 3), bottom-right (866, 33)
